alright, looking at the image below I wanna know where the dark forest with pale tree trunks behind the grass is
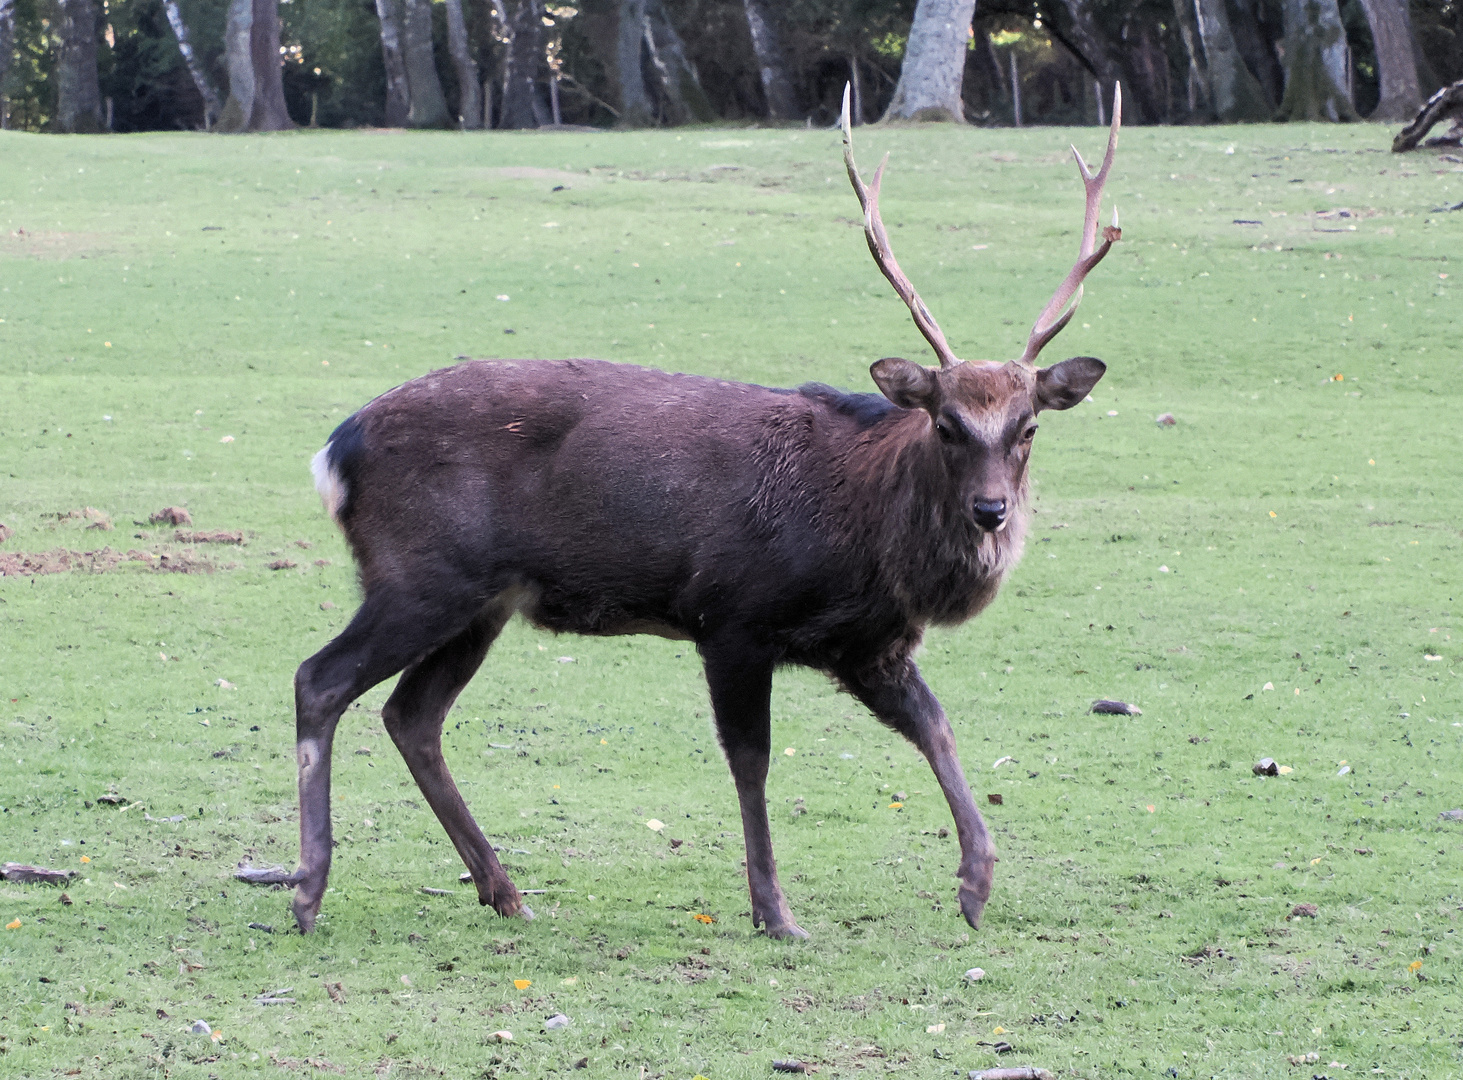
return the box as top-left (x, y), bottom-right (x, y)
top-left (0, 0), bottom-right (1463, 132)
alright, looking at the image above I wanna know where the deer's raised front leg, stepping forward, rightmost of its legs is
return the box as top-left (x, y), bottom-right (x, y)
top-left (843, 660), bottom-right (996, 929)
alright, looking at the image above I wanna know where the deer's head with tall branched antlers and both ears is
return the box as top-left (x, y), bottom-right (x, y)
top-left (843, 86), bottom-right (1122, 533)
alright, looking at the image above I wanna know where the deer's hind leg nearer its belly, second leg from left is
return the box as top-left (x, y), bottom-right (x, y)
top-left (380, 603), bottom-right (534, 919)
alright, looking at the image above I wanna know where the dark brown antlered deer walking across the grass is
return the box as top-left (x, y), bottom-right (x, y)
top-left (237, 88), bottom-right (1122, 938)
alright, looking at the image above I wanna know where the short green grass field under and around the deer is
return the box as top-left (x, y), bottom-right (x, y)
top-left (0, 126), bottom-right (1463, 1080)
